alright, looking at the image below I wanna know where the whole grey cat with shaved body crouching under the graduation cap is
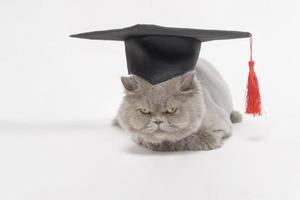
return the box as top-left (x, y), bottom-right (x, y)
top-left (116, 59), bottom-right (242, 151)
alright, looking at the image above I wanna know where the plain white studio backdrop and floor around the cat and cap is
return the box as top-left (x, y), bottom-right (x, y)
top-left (0, 0), bottom-right (300, 200)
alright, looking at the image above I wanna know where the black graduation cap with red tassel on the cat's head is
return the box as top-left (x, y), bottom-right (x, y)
top-left (71, 24), bottom-right (261, 115)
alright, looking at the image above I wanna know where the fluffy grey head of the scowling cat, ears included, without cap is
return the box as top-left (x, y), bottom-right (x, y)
top-left (118, 72), bottom-right (204, 143)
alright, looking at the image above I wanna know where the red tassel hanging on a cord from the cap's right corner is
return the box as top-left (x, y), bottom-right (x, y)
top-left (246, 35), bottom-right (261, 116)
